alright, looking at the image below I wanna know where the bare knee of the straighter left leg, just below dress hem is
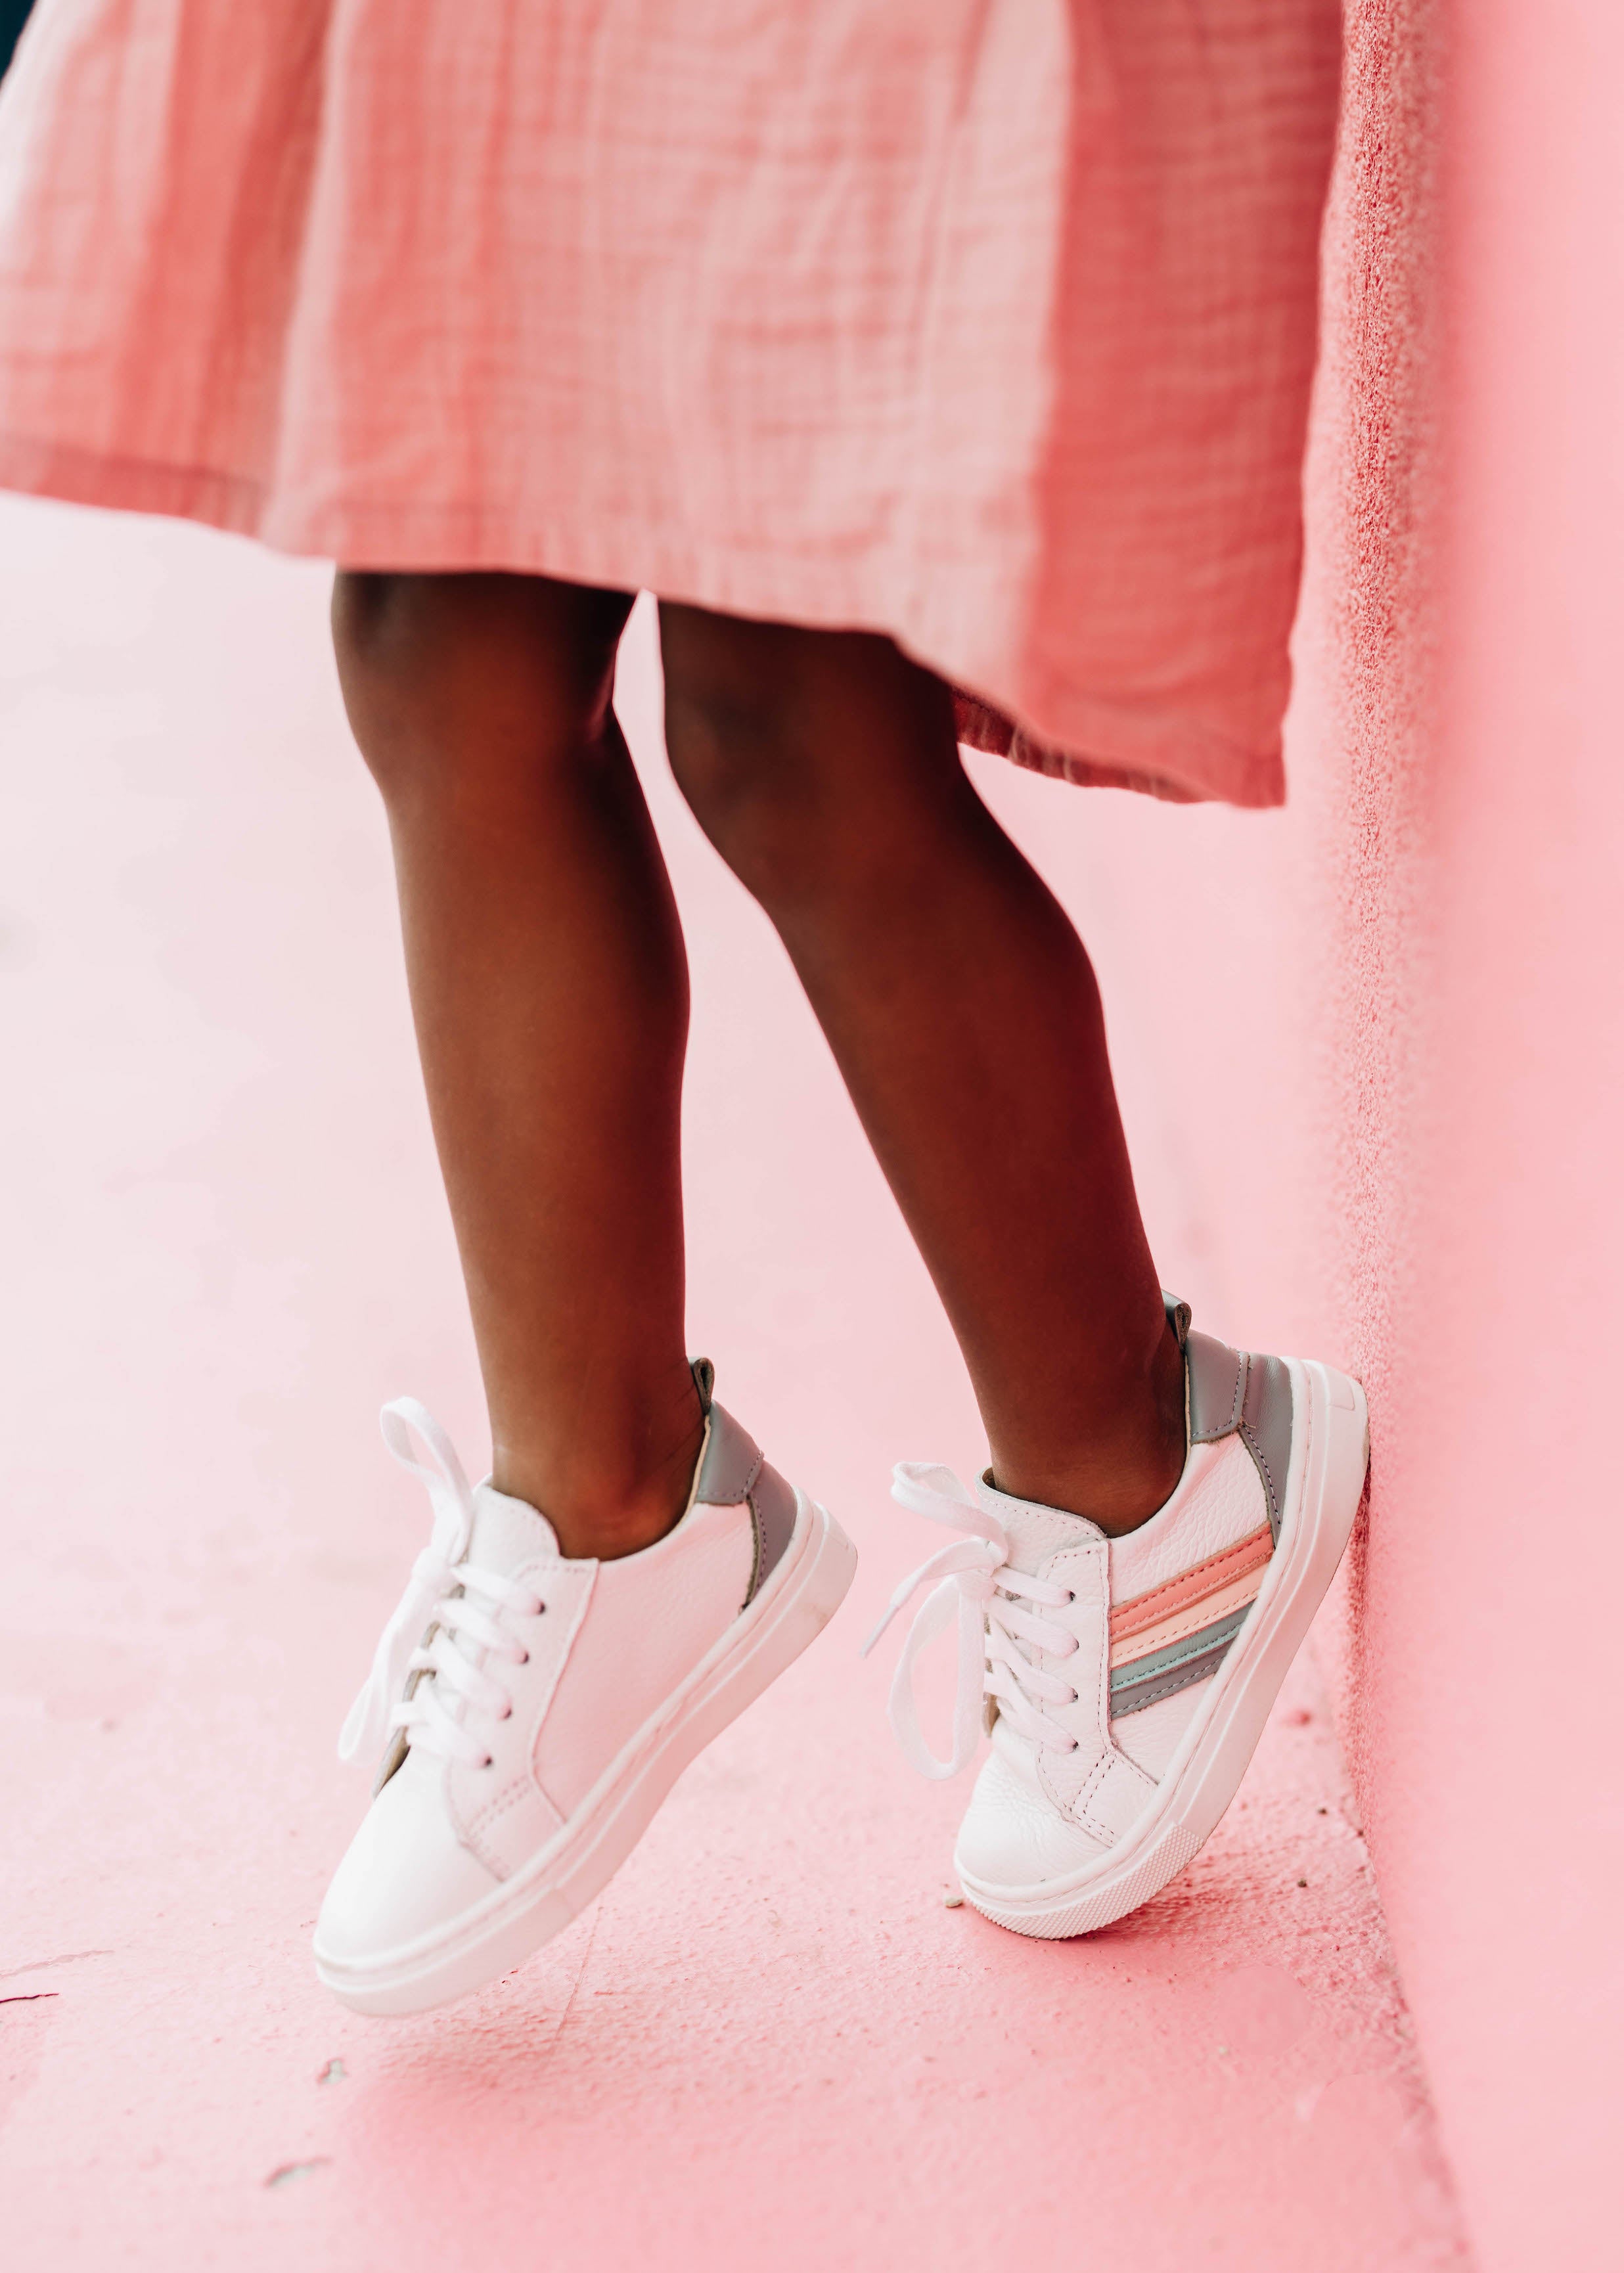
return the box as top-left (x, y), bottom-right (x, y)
top-left (332, 568), bottom-right (630, 802)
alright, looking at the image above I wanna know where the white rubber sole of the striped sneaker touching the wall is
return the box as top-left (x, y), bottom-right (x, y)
top-left (958, 1357), bottom-right (1369, 1941)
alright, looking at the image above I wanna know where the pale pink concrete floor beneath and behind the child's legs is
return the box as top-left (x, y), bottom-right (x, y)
top-left (0, 503), bottom-right (1465, 2273)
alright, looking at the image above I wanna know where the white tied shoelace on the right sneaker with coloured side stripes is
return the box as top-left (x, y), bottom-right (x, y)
top-left (862, 1459), bottom-right (1078, 1778)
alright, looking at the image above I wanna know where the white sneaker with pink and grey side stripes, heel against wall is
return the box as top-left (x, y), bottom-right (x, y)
top-left (867, 1300), bottom-right (1369, 1937)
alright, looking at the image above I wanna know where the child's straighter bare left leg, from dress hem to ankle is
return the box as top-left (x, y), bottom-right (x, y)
top-left (332, 575), bottom-right (703, 1555)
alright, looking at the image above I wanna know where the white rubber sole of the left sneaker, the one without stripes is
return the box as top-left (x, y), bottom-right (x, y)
top-left (316, 1491), bottom-right (857, 2018)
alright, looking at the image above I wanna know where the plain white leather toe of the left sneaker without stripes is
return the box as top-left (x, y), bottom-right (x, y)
top-left (316, 1755), bottom-right (501, 1966)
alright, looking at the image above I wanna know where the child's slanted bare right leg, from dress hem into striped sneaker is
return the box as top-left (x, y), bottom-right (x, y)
top-left (662, 607), bottom-right (1185, 1530)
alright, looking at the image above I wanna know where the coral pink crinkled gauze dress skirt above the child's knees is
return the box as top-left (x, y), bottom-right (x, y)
top-left (0, 0), bottom-right (1340, 805)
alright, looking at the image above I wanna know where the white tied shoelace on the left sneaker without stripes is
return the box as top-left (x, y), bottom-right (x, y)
top-left (339, 1398), bottom-right (546, 1768)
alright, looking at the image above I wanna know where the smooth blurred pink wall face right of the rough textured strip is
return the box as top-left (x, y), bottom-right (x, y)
top-left (1363, 0), bottom-right (1624, 2273)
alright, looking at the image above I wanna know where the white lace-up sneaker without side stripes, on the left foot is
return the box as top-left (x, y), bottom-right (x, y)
top-left (316, 1359), bottom-right (857, 2014)
